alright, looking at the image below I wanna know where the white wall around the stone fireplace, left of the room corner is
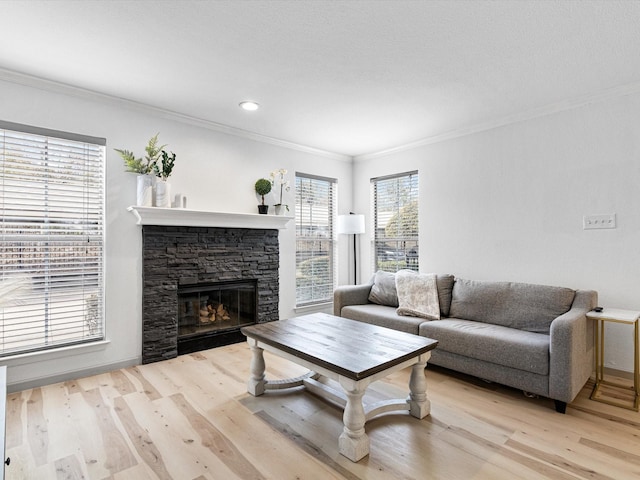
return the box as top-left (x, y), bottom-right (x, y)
top-left (0, 80), bottom-right (352, 390)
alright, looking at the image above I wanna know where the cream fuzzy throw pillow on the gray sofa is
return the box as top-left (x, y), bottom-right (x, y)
top-left (396, 271), bottom-right (440, 320)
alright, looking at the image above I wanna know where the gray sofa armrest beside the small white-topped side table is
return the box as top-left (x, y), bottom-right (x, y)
top-left (549, 290), bottom-right (598, 403)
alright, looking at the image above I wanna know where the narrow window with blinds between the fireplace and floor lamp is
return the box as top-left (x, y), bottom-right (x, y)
top-left (296, 173), bottom-right (337, 306)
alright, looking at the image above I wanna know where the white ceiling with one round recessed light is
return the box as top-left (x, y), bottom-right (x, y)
top-left (0, 0), bottom-right (640, 156)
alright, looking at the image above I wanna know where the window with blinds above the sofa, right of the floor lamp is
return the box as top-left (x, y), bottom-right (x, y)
top-left (371, 172), bottom-right (419, 272)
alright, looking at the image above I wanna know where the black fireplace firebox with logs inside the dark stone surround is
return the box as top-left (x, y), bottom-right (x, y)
top-left (178, 280), bottom-right (257, 355)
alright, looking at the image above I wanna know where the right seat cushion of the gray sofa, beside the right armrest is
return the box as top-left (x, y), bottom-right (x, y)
top-left (418, 318), bottom-right (549, 375)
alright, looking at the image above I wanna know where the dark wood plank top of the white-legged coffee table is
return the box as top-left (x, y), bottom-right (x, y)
top-left (241, 313), bottom-right (438, 380)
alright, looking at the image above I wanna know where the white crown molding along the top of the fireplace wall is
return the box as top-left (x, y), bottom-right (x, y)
top-left (0, 68), bottom-right (353, 162)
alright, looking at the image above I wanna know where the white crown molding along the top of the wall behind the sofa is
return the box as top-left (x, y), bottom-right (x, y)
top-left (353, 82), bottom-right (640, 162)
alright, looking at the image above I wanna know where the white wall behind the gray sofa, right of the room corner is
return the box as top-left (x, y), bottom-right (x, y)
top-left (354, 94), bottom-right (640, 371)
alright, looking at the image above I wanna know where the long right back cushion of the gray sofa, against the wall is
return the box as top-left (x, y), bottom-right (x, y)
top-left (449, 278), bottom-right (575, 334)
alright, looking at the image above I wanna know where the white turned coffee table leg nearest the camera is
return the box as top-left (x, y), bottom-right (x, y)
top-left (338, 377), bottom-right (369, 462)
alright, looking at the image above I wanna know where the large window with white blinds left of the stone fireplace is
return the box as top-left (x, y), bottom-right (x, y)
top-left (0, 122), bottom-right (106, 356)
